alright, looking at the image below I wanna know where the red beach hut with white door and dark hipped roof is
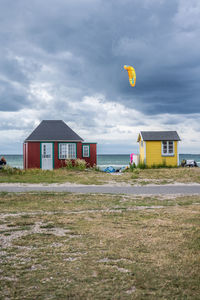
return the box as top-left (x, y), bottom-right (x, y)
top-left (23, 120), bottom-right (97, 170)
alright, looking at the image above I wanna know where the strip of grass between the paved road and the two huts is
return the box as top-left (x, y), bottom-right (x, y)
top-left (0, 168), bottom-right (200, 185)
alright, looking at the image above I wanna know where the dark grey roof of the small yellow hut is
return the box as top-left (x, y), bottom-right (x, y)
top-left (140, 131), bottom-right (181, 141)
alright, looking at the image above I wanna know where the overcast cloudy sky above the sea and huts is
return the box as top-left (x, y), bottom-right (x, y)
top-left (0, 0), bottom-right (200, 154)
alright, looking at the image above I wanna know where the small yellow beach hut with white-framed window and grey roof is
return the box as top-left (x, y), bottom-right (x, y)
top-left (137, 131), bottom-right (180, 167)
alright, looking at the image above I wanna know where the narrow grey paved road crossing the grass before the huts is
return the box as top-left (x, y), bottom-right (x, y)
top-left (0, 184), bottom-right (200, 195)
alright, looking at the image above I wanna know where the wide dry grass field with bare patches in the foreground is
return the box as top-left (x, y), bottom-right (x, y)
top-left (0, 193), bottom-right (200, 299)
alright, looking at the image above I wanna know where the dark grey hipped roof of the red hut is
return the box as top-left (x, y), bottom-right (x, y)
top-left (25, 120), bottom-right (83, 142)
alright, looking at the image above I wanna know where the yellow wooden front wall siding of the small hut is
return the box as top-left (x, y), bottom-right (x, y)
top-left (146, 141), bottom-right (178, 166)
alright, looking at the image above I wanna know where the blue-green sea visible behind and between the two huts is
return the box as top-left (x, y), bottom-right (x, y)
top-left (0, 154), bottom-right (200, 170)
